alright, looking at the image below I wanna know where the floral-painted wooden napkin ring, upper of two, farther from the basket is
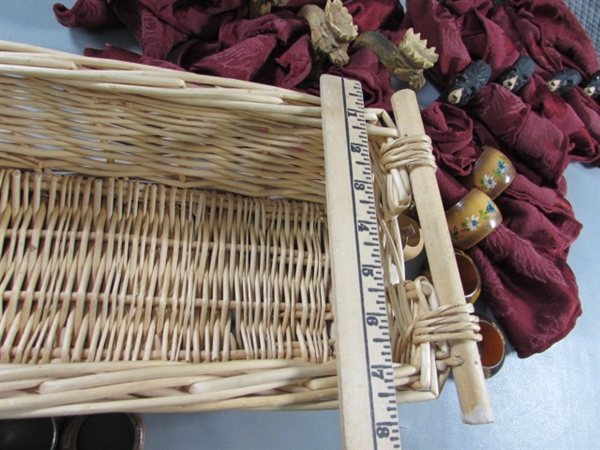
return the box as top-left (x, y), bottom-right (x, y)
top-left (464, 145), bottom-right (517, 200)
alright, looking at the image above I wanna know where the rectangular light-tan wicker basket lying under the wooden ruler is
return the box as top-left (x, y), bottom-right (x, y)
top-left (0, 42), bottom-right (478, 417)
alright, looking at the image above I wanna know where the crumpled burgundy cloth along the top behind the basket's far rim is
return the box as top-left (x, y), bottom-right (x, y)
top-left (54, 0), bottom-right (404, 110)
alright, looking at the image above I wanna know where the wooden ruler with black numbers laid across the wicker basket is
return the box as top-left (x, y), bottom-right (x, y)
top-left (321, 75), bottom-right (400, 450)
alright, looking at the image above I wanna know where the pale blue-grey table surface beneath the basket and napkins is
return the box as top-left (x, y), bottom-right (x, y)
top-left (0, 0), bottom-right (600, 450)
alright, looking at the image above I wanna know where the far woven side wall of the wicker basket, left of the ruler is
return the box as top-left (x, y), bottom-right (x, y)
top-left (0, 43), bottom-right (324, 201)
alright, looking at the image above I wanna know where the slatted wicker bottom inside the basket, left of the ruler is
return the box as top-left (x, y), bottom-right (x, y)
top-left (0, 170), bottom-right (333, 363)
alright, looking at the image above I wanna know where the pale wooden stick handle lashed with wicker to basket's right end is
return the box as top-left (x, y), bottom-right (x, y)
top-left (392, 89), bottom-right (494, 424)
